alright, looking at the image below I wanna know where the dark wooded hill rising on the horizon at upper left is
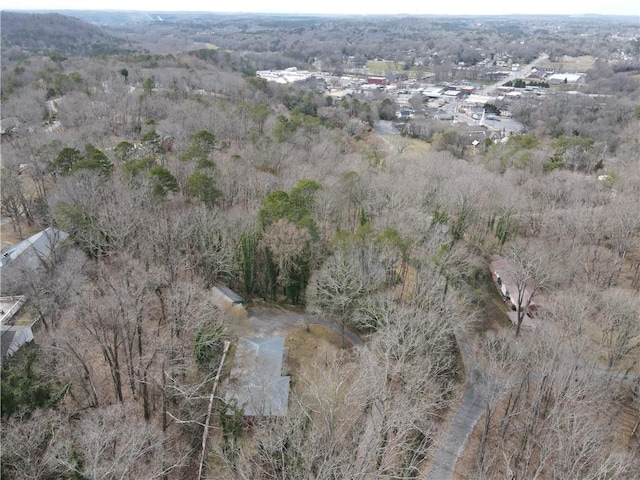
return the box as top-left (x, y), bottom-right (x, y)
top-left (0, 12), bottom-right (134, 56)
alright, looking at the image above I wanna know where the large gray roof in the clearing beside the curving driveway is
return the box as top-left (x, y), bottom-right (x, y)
top-left (226, 337), bottom-right (290, 416)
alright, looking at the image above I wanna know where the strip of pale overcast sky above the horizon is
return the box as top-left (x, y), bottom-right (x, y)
top-left (0, 0), bottom-right (640, 16)
